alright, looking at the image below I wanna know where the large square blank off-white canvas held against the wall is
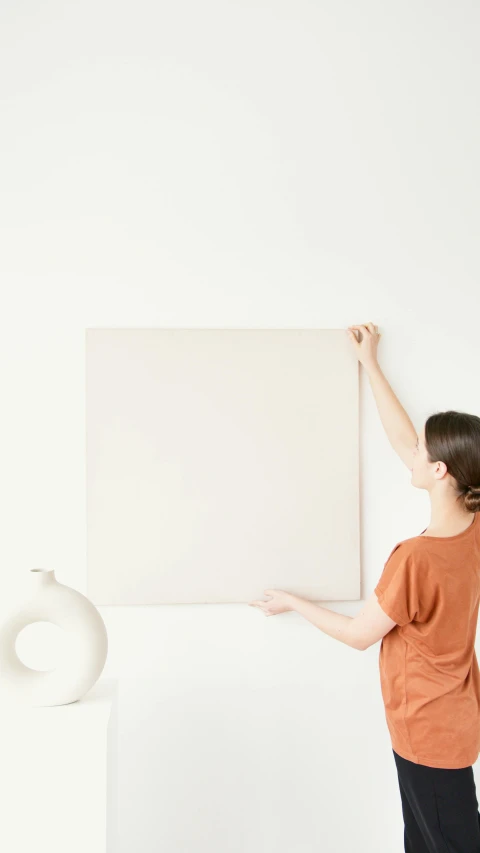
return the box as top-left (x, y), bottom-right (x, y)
top-left (86, 328), bottom-right (360, 605)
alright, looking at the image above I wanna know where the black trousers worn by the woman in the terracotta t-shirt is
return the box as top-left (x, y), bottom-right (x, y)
top-left (392, 750), bottom-right (480, 853)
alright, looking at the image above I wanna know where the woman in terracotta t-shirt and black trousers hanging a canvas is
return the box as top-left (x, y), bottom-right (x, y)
top-left (251, 323), bottom-right (480, 853)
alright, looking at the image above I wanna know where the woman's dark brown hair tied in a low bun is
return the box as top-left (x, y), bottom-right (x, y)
top-left (425, 411), bottom-right (480, 512)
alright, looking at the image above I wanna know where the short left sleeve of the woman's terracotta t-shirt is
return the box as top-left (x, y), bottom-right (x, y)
top-left (374, 543), bottom-right (420, 626)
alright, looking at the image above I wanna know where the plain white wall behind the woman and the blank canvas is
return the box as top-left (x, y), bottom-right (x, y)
top-left (0, 0), bottom-right (480, 853)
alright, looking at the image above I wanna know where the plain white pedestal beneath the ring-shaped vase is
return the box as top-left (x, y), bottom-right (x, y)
top-left (0, 679), bottom-right (118, 853)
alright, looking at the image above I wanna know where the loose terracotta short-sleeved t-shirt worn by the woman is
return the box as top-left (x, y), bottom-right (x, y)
top-left (375, 513), bottom-right (480, 769)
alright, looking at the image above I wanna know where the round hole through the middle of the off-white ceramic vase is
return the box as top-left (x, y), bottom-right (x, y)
top-left (15, 620), bottom-right (69, 672)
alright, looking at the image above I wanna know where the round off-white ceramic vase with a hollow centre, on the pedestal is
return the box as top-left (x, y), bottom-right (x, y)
top-left (0, 569), bottom-right (108, 707)
